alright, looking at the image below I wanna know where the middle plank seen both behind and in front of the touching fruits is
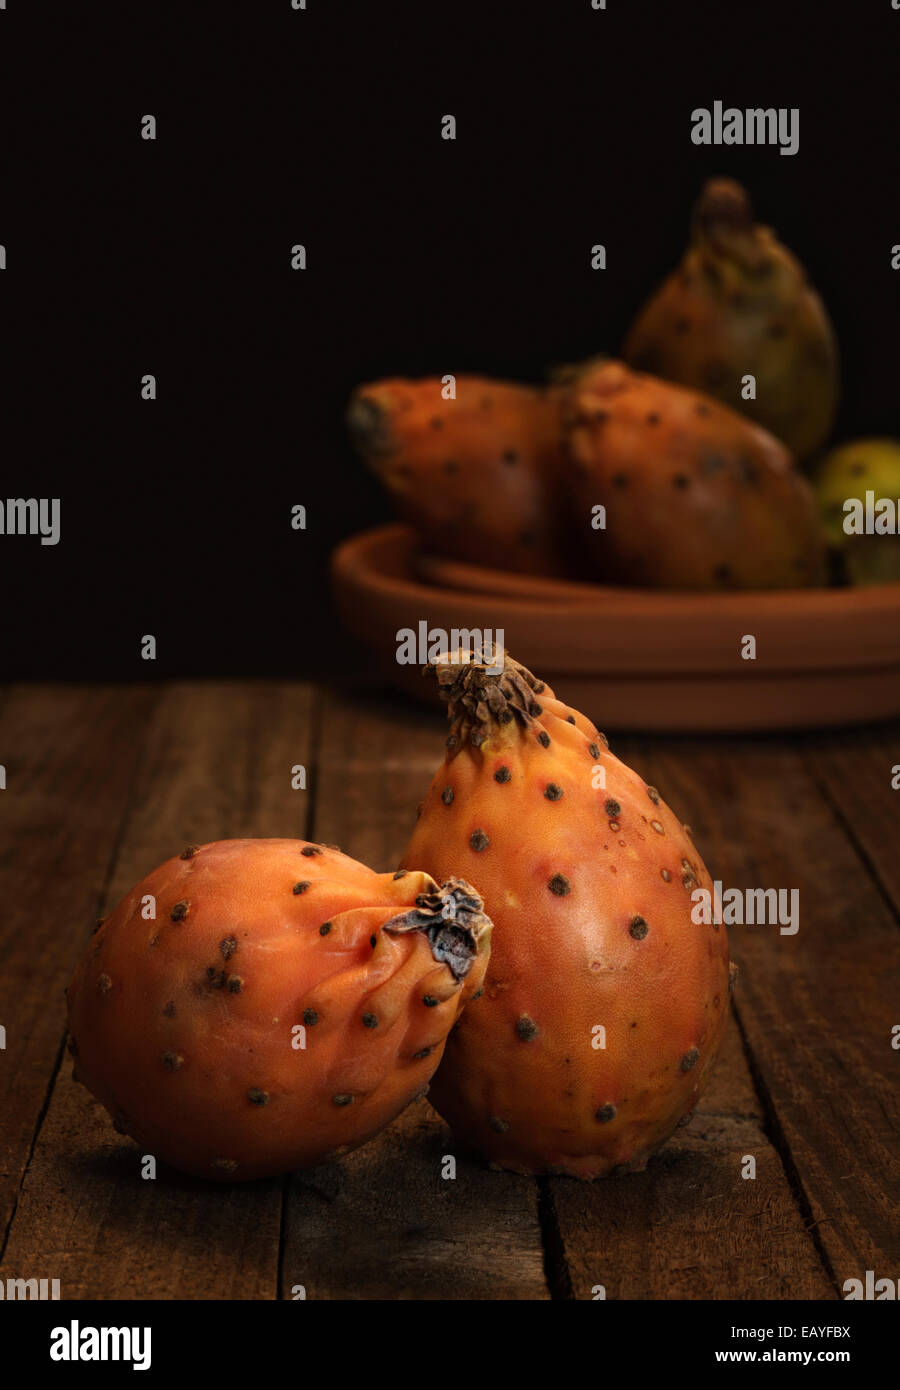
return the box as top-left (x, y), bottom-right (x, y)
top-left (282, 696), bottom-right (548, 1300)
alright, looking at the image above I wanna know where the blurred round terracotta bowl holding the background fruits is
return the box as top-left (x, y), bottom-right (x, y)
top-left (332, 525), bottom-right (900, 731)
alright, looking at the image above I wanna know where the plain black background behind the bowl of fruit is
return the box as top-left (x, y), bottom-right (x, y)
top-left (0, 0), bottom-right (900, 680)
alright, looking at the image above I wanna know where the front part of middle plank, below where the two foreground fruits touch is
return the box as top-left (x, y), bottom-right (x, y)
top-left (289, 1099), bottom-right (549, 1300)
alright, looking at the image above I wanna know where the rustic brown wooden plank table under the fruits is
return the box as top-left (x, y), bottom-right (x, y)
top-left (0, 682), bottom-right (900, 1300)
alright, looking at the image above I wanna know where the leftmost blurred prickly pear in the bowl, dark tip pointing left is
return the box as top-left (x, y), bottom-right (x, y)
top-left (348, 377), bottom-right (563, 574)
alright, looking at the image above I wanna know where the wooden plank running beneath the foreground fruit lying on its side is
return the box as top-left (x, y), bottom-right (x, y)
top-left (0, 684), bottom-right (312, 1298)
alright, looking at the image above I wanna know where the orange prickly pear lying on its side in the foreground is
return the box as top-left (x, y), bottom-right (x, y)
top-left (68, 840), bottom-right (491, 1182)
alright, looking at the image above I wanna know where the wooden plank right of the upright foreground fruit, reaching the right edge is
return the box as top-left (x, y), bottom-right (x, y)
top-left (613, 738), bottom-right (900, 1291)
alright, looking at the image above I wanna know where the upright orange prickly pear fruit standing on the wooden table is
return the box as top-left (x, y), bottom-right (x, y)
top-left (402, 653), bottom-right (729, 1179)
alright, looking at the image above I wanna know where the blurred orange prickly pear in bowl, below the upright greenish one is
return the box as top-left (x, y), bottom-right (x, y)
top-left (565, 361), bottom-right (825, 589)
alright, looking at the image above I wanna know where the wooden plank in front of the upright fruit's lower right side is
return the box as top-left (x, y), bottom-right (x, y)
top-left (549, 1019), bottom-right (835, 1300)
